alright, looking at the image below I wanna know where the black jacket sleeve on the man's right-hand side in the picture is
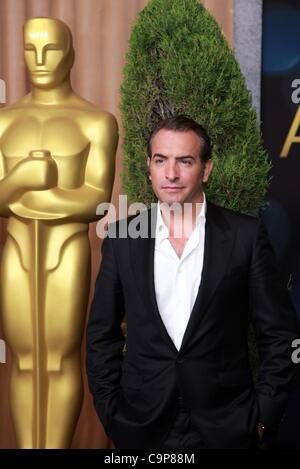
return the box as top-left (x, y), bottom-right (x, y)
top-left (250, 222), bottom-right (298, 427)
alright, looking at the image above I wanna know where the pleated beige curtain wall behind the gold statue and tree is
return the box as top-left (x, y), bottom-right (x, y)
top-left (0, 0), bottom-right (233, 448)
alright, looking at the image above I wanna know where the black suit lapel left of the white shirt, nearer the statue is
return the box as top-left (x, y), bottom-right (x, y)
top-left (129, 207), bottom-right (178, 353)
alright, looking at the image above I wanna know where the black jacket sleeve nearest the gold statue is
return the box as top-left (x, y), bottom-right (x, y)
top-left (86, 237), bottom-right (125, 432)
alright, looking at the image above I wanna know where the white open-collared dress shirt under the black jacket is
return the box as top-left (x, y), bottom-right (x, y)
top-left (154, 194), bottom-right (206, 350)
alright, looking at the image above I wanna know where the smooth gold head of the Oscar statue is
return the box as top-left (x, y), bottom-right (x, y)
top-left (24, 18), bottom-right (74, 89)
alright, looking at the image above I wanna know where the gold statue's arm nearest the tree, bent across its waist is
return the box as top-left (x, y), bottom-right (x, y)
top-left (11, 114), bottom-right (118, 222)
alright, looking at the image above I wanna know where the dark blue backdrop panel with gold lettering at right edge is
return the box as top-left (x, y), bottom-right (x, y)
top-left (261, 0), bottom-right (300, 449)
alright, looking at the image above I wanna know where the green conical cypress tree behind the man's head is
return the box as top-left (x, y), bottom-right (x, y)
top-left (121, 0), bottom-right (270, 212)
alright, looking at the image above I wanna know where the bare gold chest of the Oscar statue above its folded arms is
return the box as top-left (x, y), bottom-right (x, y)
top-left (1, 107), bottom-right (90, 189)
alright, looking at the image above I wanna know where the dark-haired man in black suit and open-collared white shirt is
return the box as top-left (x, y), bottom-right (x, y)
top-left (87, 116), bottom-right (296, 449)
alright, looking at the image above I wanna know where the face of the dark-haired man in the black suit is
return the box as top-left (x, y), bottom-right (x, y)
top-left (148, 129), bottom-right (212, 204)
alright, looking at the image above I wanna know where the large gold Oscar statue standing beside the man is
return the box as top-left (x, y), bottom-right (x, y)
top-left (0, 18), bottom-right (118, 448)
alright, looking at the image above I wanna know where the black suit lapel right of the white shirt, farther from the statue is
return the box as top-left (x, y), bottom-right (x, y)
top-left (180, 202), bottom-right (235, 352)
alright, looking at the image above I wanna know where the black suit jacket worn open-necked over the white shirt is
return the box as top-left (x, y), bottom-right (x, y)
top-left (87, 202), bottom-right (297, 448)
